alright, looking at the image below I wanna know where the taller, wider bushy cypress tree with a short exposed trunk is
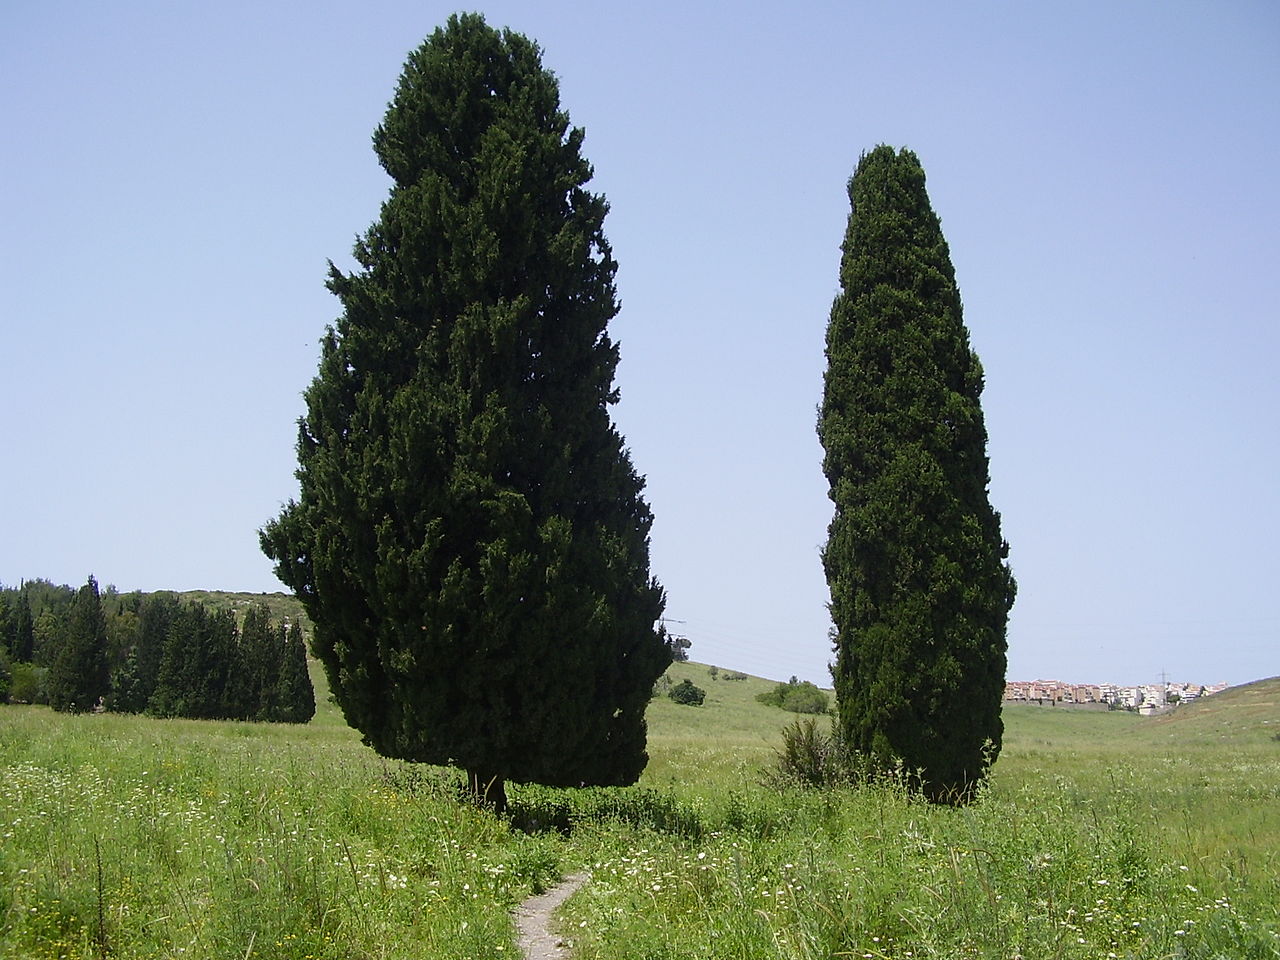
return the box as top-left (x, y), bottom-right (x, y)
top-left (262, 15), bottom-right (671, 803)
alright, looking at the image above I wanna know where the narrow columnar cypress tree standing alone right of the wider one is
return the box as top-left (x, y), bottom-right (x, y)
top-left (818, 146), bottom-right (1014, 801)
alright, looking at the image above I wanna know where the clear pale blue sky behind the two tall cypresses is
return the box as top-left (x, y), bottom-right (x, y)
top-left (0, 0), bottom-right (1280, 682)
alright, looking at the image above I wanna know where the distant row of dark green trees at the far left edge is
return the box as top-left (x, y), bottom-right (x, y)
top-left (0, 577), bottom-right (315, 723)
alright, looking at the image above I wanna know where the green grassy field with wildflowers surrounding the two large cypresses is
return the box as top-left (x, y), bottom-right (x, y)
top-left (0, 663), bottom-right (1280, 960)
